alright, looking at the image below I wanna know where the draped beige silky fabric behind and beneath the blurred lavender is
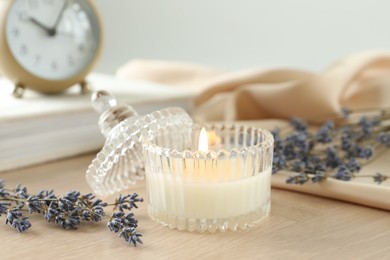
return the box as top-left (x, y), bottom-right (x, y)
top-left (117, 51), bottom-right (390, 210)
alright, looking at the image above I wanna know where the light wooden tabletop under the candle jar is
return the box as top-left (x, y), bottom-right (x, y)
top-left (0, 155), bottom-right (390, 259)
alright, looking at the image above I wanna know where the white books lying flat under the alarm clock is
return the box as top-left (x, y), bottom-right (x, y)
top-left (0, 73), bottom-right (196, 171)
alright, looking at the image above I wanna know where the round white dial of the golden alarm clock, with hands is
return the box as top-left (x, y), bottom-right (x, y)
top-left (6, 0), bottom-right (100, 80)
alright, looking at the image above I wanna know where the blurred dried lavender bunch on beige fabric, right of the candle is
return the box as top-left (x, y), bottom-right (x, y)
top-left (273, 109), bottom-right (390, 184)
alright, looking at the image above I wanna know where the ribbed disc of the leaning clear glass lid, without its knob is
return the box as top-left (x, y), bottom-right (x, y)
top-left (86, 107), bottom-right (192, 196)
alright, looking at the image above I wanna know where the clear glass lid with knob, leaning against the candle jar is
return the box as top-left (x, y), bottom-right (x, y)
top-left (86, 91), bottom-right (192, 196)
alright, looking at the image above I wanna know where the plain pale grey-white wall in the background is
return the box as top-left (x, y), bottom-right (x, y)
top-left (95, 0), bottom-right (390, 73)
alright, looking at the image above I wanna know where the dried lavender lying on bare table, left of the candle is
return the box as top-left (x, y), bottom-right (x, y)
top-left (0, 180), bottom-right (143, 246)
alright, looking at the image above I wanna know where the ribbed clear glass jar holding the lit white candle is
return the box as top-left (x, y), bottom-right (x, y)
top-left (143, 124), bottom-right (273, 232)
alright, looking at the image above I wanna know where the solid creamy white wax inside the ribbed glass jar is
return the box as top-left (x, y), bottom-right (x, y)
top-left (147, 169), bottom-right (271, 219)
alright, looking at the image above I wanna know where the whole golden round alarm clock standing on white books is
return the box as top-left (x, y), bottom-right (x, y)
top-left (0, 0), bottom-right (103, 97)
